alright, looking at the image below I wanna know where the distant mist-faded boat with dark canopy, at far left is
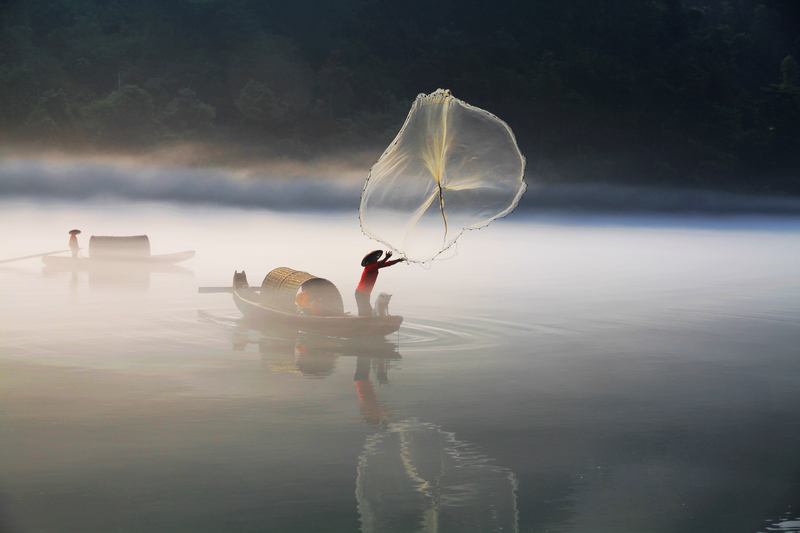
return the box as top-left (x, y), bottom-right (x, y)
top-left (42, 235), bottom-right (195, 270)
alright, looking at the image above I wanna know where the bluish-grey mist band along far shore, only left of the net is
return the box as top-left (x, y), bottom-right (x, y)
top-left (0, 153), bottom-right (366, 210)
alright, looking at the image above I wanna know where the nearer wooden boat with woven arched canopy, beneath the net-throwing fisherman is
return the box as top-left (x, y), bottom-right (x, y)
top-left (233, 267), bottom-right (403, 338)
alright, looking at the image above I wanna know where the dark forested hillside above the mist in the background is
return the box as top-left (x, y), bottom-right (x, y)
top-left (0, 0), bottom-right (800, 193)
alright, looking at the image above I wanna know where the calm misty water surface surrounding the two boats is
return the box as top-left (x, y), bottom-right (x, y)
top-left (0, 197), bottom-right (800, 533)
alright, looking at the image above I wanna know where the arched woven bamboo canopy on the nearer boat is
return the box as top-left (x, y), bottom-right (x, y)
top-left (261, 267), bottom-right (344, 315)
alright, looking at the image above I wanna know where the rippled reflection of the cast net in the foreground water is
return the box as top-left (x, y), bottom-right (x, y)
top-left (356, 419), bottom-right (519, 533)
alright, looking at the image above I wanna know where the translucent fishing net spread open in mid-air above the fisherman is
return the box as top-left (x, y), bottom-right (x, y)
top-left (360, 89), bottom-right (525, 263)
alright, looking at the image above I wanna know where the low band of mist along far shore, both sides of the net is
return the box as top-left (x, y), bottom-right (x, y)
top-left (0, 158), bottom-right (800, 215)
